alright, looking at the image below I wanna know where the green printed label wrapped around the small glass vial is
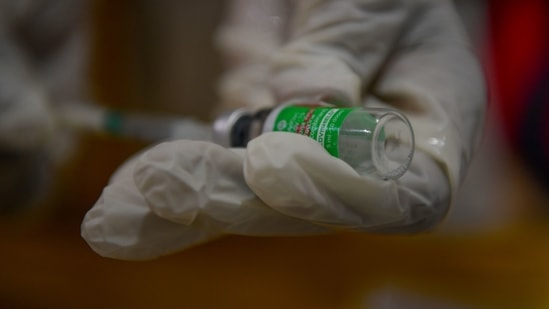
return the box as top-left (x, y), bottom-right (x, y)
top-left (273, 105), bottom-right (355, 157)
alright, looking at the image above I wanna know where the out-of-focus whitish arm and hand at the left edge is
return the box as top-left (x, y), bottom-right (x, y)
top-left (0, 0), bottom-right (86, 213)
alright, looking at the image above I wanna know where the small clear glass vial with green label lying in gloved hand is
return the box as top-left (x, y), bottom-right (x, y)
top-left (213, 104), bottom-right (415, 179)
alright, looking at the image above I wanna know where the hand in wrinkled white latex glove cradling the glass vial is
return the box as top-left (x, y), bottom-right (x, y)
top-left (82, 0), bottom-right (485, 260)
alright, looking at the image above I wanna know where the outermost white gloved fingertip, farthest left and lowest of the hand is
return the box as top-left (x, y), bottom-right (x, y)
top-left (81, 156), bottom-right (216, 260)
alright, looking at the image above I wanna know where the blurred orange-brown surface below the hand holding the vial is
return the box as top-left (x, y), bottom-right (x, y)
top-left (0, 169), bottom-right (549, 308)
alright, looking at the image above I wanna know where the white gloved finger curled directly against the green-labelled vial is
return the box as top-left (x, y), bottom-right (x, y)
top-left (244, 132), bottom-right (403, 228)
